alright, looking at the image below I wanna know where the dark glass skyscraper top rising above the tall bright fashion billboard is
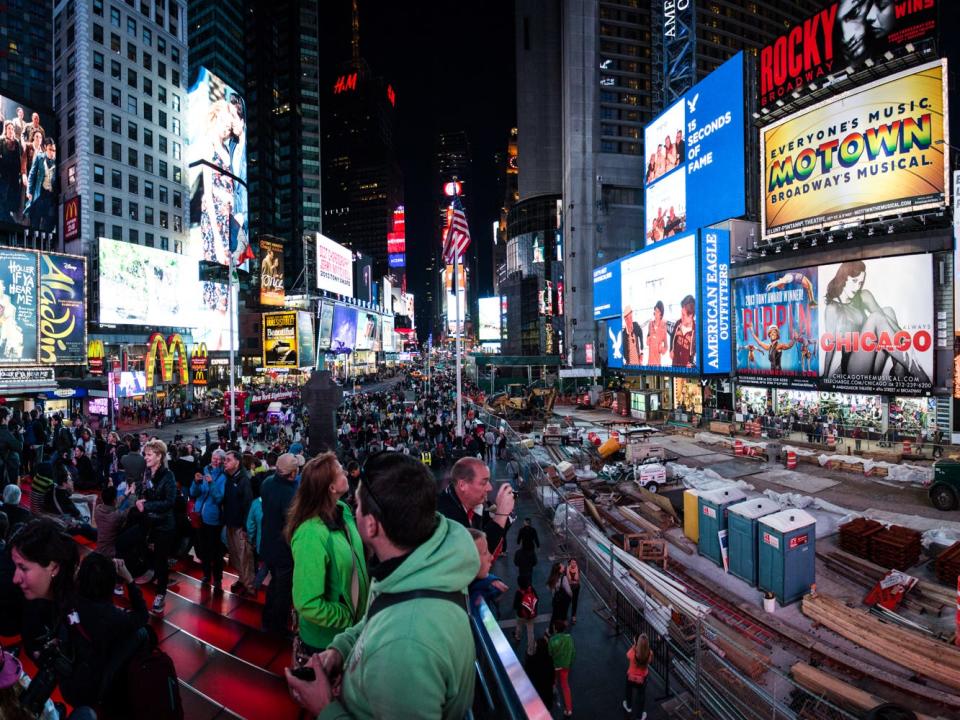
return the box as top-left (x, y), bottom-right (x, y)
top-left (188, 0), bottom-right (246, 93)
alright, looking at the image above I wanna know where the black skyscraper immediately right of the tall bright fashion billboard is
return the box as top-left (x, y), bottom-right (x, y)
top-left (245, 0), bottom-right (321, 290)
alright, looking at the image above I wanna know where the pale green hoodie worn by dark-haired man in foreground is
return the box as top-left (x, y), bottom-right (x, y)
top-left (320, 514), bottom-right (480, 720)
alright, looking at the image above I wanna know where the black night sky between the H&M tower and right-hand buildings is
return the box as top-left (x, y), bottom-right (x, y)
top-left (352, 0), bottom-right (516, 331)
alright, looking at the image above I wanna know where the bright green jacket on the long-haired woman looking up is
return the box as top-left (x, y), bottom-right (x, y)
top-left (290, 502), bottom-right (370, 650)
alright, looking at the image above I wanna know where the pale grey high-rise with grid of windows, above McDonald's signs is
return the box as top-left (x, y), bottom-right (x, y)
top-left (54, 0), bottom-right (188, 262)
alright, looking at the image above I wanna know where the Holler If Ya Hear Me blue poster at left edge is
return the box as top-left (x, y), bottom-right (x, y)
top-left (0, 248), bottom-right (37, 364)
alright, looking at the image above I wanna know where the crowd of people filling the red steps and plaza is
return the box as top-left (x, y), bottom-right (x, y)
top-left (0, 375), bottom-right (668, 719)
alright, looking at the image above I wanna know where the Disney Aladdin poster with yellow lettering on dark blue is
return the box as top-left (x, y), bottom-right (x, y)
top-left (39, 253), bottom-right (87, 365)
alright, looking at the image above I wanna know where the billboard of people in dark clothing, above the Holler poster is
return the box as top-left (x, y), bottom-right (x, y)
top-left (0, 95), bottom-right (57, 232)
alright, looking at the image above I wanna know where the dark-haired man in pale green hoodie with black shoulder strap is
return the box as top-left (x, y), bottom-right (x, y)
top-left (286, 453), bottom-right (479, 720)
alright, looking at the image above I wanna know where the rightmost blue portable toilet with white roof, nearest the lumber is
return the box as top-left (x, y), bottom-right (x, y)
top-left (757, 508), bottom-right (817, 605)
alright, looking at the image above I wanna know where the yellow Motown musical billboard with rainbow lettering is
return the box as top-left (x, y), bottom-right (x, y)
top-left (760, 61), bottom-right (949, 238)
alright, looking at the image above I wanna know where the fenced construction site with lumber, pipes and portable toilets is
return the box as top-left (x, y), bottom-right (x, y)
top-left (481, 403), bottom-right (960, 720)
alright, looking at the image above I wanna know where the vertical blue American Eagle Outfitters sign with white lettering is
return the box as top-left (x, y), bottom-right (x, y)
top-left (700, 229), bottom-right (731, 374)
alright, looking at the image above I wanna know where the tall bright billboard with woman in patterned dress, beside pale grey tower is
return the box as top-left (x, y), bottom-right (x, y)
top-left (184, 67), bottom-right (252, 265)
